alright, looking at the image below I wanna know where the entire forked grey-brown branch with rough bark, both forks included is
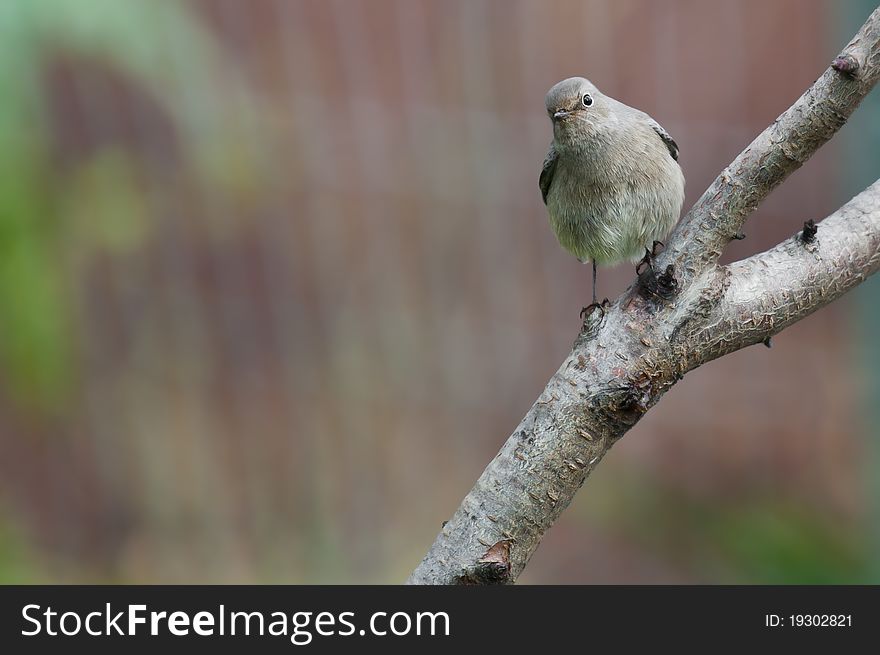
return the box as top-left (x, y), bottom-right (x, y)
top-left (407, 9), bottom-right (880, 584)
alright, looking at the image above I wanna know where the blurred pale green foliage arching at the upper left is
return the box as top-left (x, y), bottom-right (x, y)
top-left (0, 0), bottom-right (253, 411)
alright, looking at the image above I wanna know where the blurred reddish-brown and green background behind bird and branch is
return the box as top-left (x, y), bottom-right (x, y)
top-left (0, 0), bottom-right (880, 583)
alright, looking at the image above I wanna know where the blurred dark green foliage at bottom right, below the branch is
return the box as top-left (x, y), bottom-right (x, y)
top-left (592, 472), bottom-right (872, 584)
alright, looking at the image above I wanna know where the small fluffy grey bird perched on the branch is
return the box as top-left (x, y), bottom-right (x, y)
top-left (539, 77), bottom-right (684, 306)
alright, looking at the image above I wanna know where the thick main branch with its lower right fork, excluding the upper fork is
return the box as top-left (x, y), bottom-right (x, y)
top-left (409, 181), bottom-right (880, 584)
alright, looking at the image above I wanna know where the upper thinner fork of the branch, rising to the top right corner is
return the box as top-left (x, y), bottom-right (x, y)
top-left (659, 7), bottom-right (880, 286)
